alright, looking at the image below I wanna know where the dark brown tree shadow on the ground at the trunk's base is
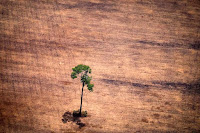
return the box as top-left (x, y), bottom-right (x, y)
top-left (62, 111), bottom-right (85, 128)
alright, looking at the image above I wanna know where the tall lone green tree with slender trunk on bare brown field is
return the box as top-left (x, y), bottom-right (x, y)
top-left (71, 64), bottom-right (94, 116)
